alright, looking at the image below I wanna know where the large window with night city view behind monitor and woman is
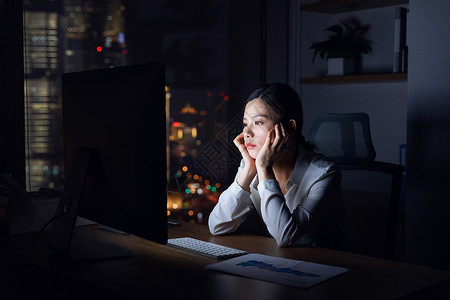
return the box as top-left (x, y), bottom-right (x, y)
top-left (23, 0), bottom-right (237, 223)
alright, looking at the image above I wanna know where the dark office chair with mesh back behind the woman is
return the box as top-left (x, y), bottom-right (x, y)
top-left (307, 113), bottom-right (403, 259)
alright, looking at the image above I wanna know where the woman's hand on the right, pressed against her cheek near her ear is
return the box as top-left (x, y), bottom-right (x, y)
top-left (256, 124), bottom-right (291, 179)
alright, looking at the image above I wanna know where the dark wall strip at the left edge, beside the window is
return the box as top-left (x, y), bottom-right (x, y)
top-left (0, 0), bottom-right (25, 186)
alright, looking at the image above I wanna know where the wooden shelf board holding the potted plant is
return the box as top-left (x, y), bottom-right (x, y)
top-left (300, 73), bottom-right (408, 84)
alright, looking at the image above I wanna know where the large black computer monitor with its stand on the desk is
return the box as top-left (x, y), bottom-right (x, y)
top-left (47, 63), bottom-right (167, 258)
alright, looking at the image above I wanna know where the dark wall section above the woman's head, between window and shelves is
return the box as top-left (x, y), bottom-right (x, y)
top-left (229, 0), bottom-right (290, 118)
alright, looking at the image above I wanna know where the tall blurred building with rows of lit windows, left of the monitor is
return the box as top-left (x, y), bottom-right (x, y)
top-left (24, 1), bottom-right (63, 190)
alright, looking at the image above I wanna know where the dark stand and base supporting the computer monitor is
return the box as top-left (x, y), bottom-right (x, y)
top-left (47, 148), bottom-right (134, 260)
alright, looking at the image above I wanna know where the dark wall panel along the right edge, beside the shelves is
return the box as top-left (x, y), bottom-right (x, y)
top-left (405, 0), bottom-right (450, 269)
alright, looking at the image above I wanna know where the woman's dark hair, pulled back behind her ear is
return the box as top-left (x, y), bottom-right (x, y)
top-left (244, 82), bottom-right (314, 151)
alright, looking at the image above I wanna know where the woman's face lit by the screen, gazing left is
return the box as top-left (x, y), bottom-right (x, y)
top-left (243, 98), bottom-right (280, 159)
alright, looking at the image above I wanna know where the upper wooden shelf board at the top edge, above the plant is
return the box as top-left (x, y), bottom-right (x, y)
top-left (300, 0), bottom-right (409, 14)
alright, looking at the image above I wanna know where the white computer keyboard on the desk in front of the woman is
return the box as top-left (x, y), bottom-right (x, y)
top-left (167, 237), bottom-right (248, 259)
